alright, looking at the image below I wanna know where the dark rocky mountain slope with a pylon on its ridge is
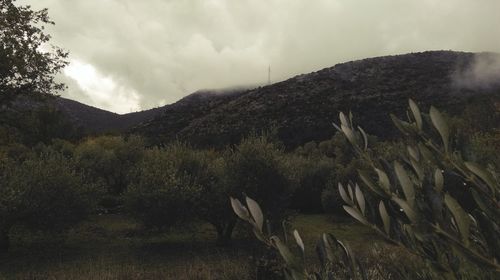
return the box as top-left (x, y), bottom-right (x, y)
top-left (131, 51), bottom-right (500, 148)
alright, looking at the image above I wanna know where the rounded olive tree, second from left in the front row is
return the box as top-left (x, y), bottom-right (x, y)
top-left (124, 146), bottom-right (198, 230)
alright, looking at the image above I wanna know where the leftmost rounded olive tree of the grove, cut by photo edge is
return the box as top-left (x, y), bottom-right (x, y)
top-left (0, 149), bottom-right (94, 249)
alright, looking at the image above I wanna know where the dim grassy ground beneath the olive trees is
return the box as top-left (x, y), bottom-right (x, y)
top-left (0, 215), bottom-right (422, 279)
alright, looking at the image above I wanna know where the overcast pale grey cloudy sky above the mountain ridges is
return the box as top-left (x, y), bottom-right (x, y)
top-left (17, 0), bottom-right (500, 113)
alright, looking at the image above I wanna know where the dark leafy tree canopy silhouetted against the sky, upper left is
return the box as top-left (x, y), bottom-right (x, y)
top-left (0, 0), bottom-right (68, 104)
